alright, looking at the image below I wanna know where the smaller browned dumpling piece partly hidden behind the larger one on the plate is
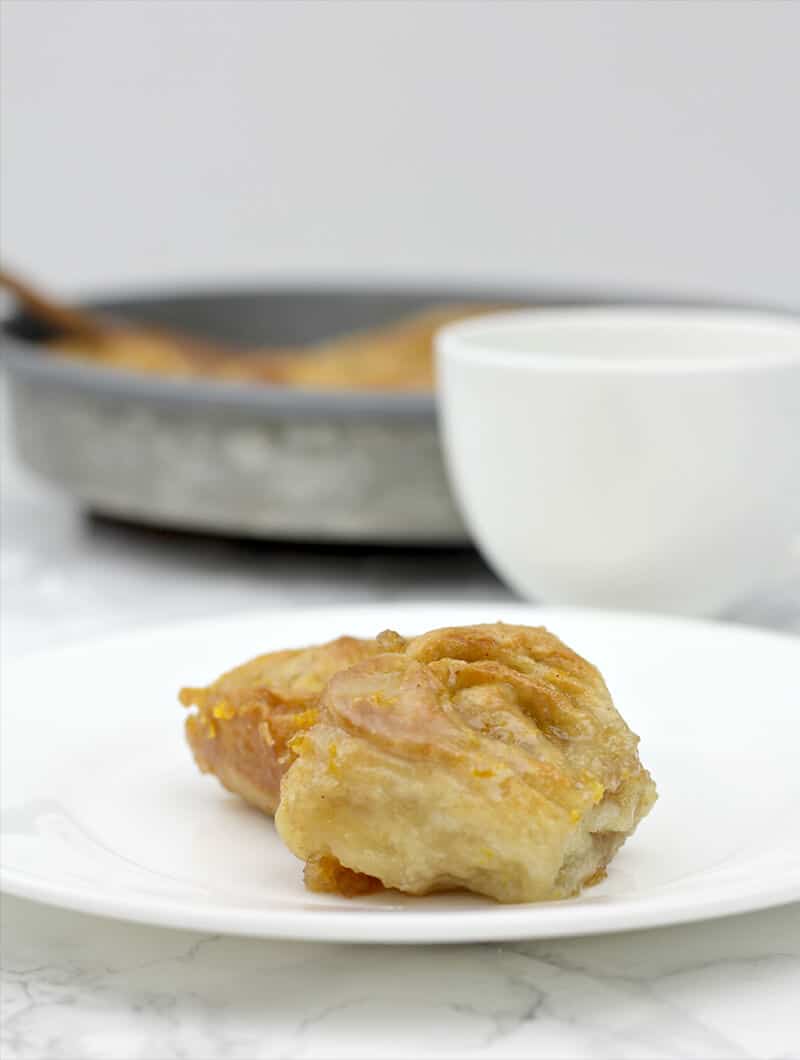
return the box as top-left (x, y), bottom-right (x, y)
top-left (179, 637), bottom-right (402, 813)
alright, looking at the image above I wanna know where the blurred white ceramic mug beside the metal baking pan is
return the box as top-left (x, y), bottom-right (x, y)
top-left (437, 306), bottom-right (800, 615)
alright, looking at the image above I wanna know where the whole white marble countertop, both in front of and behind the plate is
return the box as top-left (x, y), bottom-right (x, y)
top-left (0, 387), bottom-right (800, 1060)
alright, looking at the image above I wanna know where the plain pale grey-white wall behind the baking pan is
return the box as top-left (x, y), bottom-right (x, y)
top-left (0, 0), bottom-right (800, 306)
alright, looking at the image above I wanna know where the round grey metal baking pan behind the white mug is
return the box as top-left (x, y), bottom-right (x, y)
top-left (0, 286), bottom-right (771, 545)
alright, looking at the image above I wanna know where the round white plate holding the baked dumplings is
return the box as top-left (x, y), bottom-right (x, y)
top-left (2, 604), bottom-right (800, 942)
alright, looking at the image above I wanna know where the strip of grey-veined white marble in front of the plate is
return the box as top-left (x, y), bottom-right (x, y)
top-left (2, 899), bottom-right (800, 1060)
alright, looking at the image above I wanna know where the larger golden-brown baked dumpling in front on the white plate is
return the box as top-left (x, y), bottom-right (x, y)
top-left (275, 623), bottom-right (655, 901)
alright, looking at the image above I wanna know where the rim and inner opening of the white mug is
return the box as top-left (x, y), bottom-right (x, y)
top-left (435, 304), bottom-right (800, 374)
